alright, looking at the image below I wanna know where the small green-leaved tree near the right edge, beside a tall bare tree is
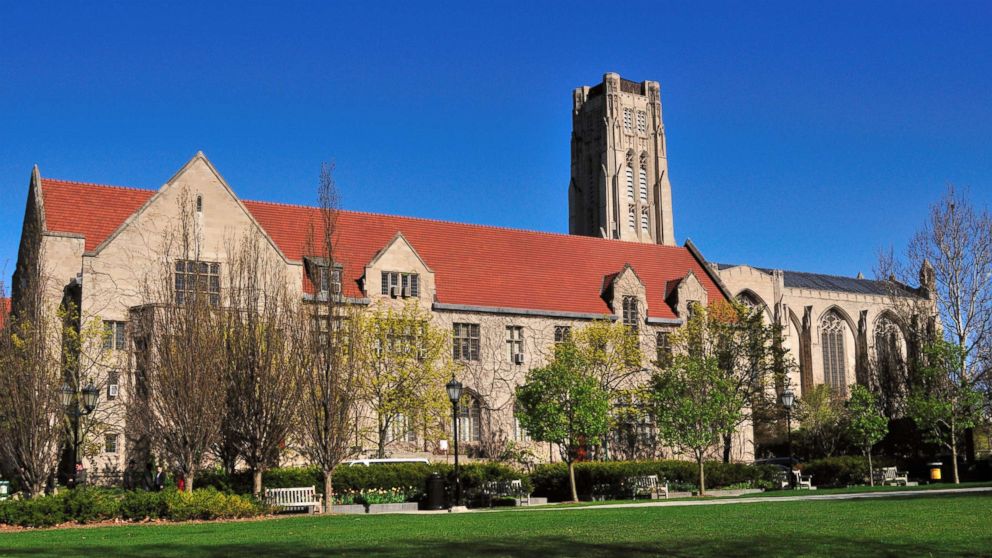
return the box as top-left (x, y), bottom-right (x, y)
top-left (907, 341), bottom-right (983, 484)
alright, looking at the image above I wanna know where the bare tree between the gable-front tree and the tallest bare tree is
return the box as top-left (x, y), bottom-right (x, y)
top-left (221, 231), bottom-right (301, 496)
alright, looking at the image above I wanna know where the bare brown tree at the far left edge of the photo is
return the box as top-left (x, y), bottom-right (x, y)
top-left (0, 228), bottom-right (66, 497)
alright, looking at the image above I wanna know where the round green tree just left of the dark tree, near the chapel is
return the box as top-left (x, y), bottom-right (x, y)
top-left (651, 354), bottom-right (745, 496)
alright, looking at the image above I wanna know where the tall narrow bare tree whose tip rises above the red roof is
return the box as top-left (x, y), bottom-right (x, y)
top-left (291, 164), bottom-right (358, 513)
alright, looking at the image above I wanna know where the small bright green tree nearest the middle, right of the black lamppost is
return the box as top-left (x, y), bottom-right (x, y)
top-left (517, 342), bottom-right (609, 501)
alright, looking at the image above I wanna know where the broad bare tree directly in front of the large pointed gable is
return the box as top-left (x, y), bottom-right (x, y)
top-left (128, 191), bottom-right (226, 491)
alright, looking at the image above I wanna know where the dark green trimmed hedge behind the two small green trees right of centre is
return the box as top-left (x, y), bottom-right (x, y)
top-left (531, 460), bottom-right (778, 501)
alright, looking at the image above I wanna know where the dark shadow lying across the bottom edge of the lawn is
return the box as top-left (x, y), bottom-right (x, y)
top-left (0, 534), bottom-right (992, 558)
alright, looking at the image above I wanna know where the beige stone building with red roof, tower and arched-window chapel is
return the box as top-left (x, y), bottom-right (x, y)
top-left (5, 74), bottom-right (919, 476)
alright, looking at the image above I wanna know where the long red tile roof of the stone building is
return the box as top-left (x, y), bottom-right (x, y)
top-left (42, 179), bottom-right (723, 318)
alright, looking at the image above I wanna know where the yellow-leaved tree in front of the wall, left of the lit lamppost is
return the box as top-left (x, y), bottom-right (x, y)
top-left (356, 302), bottom-right (451, 458)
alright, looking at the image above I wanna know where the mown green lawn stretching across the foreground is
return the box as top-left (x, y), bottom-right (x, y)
top-left (0, 494), bottom-right (992, 558)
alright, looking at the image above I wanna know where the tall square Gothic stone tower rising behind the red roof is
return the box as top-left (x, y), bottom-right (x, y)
top-left (568, 73), bottom-right (675, 245)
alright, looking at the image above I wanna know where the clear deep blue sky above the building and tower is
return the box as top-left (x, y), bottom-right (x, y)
top-left (0, 0), bottom-right (992, 288)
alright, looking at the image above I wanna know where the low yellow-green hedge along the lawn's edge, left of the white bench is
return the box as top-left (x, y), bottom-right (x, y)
top-left (0, 486), bottom-right (265, 527)
